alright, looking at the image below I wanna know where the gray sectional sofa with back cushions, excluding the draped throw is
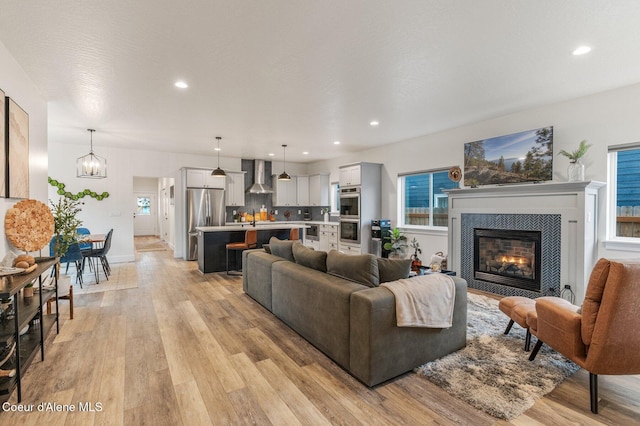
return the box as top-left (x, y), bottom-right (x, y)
top-left (242, 241), bottom-right (467, 386)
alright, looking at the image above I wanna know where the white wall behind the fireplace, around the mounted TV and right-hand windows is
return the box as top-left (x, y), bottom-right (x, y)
top-left (309, 84), bottom-right (640, 261)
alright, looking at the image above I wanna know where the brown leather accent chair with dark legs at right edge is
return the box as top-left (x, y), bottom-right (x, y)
top-left (527, 259), bottom-right (640, 414)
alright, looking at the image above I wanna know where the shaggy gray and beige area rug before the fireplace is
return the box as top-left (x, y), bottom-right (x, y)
top-left (416, 293), bottom-right (579, 420)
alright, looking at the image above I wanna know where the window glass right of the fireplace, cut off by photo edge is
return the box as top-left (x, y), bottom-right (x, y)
top-left (609, 144), bottom-right (640, 242)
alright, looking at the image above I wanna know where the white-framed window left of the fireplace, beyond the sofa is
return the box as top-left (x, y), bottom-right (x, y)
top-left (398, 170), bottom-right (458, 228)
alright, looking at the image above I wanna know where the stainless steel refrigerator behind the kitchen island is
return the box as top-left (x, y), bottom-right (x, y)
top-left (187, 188), bottom-right (226, 260)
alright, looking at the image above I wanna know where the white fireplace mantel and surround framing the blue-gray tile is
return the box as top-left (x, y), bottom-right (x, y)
top-left (447, 181), bottom-right (605, 304)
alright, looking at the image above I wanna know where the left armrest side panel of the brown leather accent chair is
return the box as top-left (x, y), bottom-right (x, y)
top-left (536, 297), bottom-right (586, 364)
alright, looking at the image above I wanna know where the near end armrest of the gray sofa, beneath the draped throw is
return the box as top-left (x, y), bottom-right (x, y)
top-left (349, 278), bottom-right (467, 386)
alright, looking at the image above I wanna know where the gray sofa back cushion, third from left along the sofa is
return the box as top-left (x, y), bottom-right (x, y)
top-left (327, 250), bottom-right (380, 287)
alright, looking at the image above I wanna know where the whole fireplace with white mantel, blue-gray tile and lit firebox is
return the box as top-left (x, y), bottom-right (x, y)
top-left (448, 182), bottom-right (604, 304)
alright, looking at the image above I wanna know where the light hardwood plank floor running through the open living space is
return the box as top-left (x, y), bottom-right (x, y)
top-left (0, 238), bottom-right (640, 425)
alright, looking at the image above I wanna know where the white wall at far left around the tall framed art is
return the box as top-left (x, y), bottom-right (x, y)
top-left (0, 42), bottom-right (49, 258)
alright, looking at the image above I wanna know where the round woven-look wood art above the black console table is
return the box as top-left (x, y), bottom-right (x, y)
top-left (4, 200), bottom-right (54, 252)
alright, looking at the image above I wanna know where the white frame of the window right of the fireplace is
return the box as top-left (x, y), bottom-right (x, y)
top-left (604, 143), bottom-right (640, 252)
